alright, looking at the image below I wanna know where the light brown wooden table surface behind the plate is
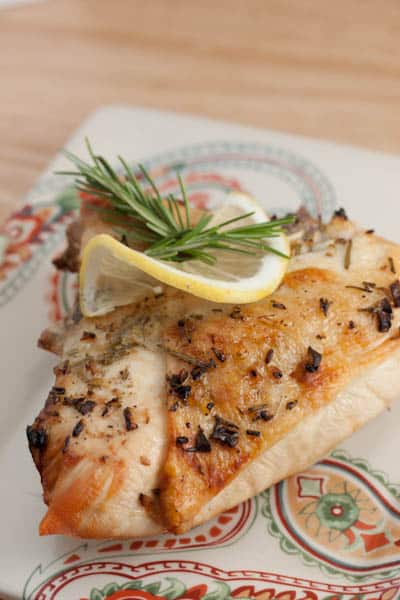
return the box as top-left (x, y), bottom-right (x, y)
top-left (0, 0), bottom-right (400, 217)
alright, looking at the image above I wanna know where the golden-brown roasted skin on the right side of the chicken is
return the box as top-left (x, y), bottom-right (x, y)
top-left (161, 267), bottom-right (400, 532)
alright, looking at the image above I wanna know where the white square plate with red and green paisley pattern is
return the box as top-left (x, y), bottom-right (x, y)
top-left (0, 106), bottom-right (400, 600)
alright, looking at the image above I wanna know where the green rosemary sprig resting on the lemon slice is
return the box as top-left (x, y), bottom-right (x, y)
top-left (59, 140), bottom-right (293, 264)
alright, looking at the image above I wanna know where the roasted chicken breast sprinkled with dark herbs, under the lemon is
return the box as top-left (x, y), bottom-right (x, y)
top-left (28, 212), bottom-right (400, 538)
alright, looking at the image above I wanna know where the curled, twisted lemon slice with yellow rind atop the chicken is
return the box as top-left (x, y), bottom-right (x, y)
top-left (80, 193), bottom-right (290, 317)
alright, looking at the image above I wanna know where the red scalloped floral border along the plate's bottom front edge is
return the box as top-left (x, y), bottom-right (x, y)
top-left (28, 560), bottom-right (400, 600)
